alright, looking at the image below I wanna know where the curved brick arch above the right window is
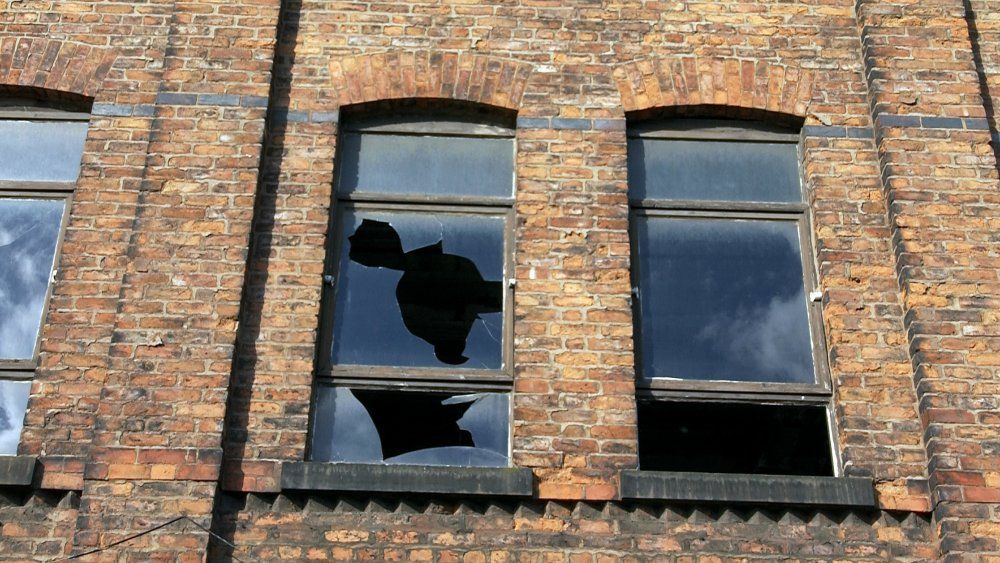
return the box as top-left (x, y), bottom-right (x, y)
top-left (614, 57), bottom-right (813, 117)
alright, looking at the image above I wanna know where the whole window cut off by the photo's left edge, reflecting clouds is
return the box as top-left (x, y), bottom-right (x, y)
top-left (0, 99), bottom-right (88, 455)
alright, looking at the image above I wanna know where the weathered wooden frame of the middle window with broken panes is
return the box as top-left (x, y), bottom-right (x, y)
top-left (305, 108), bottom-right (517, 471)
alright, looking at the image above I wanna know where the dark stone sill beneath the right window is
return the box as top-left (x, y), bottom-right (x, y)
top-left (621, 470), bottom-right (877, 508)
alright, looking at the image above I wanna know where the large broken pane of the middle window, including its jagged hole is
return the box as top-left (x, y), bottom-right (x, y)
top-left (330, 211), bottom-right (504, 369)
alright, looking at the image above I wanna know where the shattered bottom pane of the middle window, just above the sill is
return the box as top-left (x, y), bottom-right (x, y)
top-left (311, 386), bottom-right (510, 467)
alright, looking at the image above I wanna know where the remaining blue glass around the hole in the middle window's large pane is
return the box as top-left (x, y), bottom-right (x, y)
top-left (330, 211), bottom-right (504, 369)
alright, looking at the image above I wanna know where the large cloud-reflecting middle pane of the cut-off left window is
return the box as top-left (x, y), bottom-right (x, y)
top-left (0, 198), bottom-right (66, 359)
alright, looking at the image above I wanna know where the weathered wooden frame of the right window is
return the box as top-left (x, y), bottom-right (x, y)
top-left (627, 117), bottom-right (843, 476)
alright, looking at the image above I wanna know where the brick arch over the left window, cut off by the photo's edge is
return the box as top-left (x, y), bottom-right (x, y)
top-left (0, 37), bottom-right (118, 98)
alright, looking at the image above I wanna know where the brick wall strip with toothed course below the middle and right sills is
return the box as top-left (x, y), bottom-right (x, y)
top-left (213, 494), bottom-right (936, 563)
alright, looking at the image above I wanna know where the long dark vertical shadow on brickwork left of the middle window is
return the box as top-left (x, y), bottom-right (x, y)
top-left (206, 0), bottom-right (302, 561)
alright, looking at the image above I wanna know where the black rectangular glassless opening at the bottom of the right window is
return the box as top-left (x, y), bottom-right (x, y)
top-left (638, 400), bottom-right (833, 476)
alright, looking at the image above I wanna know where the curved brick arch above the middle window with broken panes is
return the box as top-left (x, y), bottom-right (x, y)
top-left (330, 52), bottom-right (532, 110)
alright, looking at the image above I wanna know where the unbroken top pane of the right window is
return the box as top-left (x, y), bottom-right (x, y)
top-left (628, 139), bottom-right (802, 202)
